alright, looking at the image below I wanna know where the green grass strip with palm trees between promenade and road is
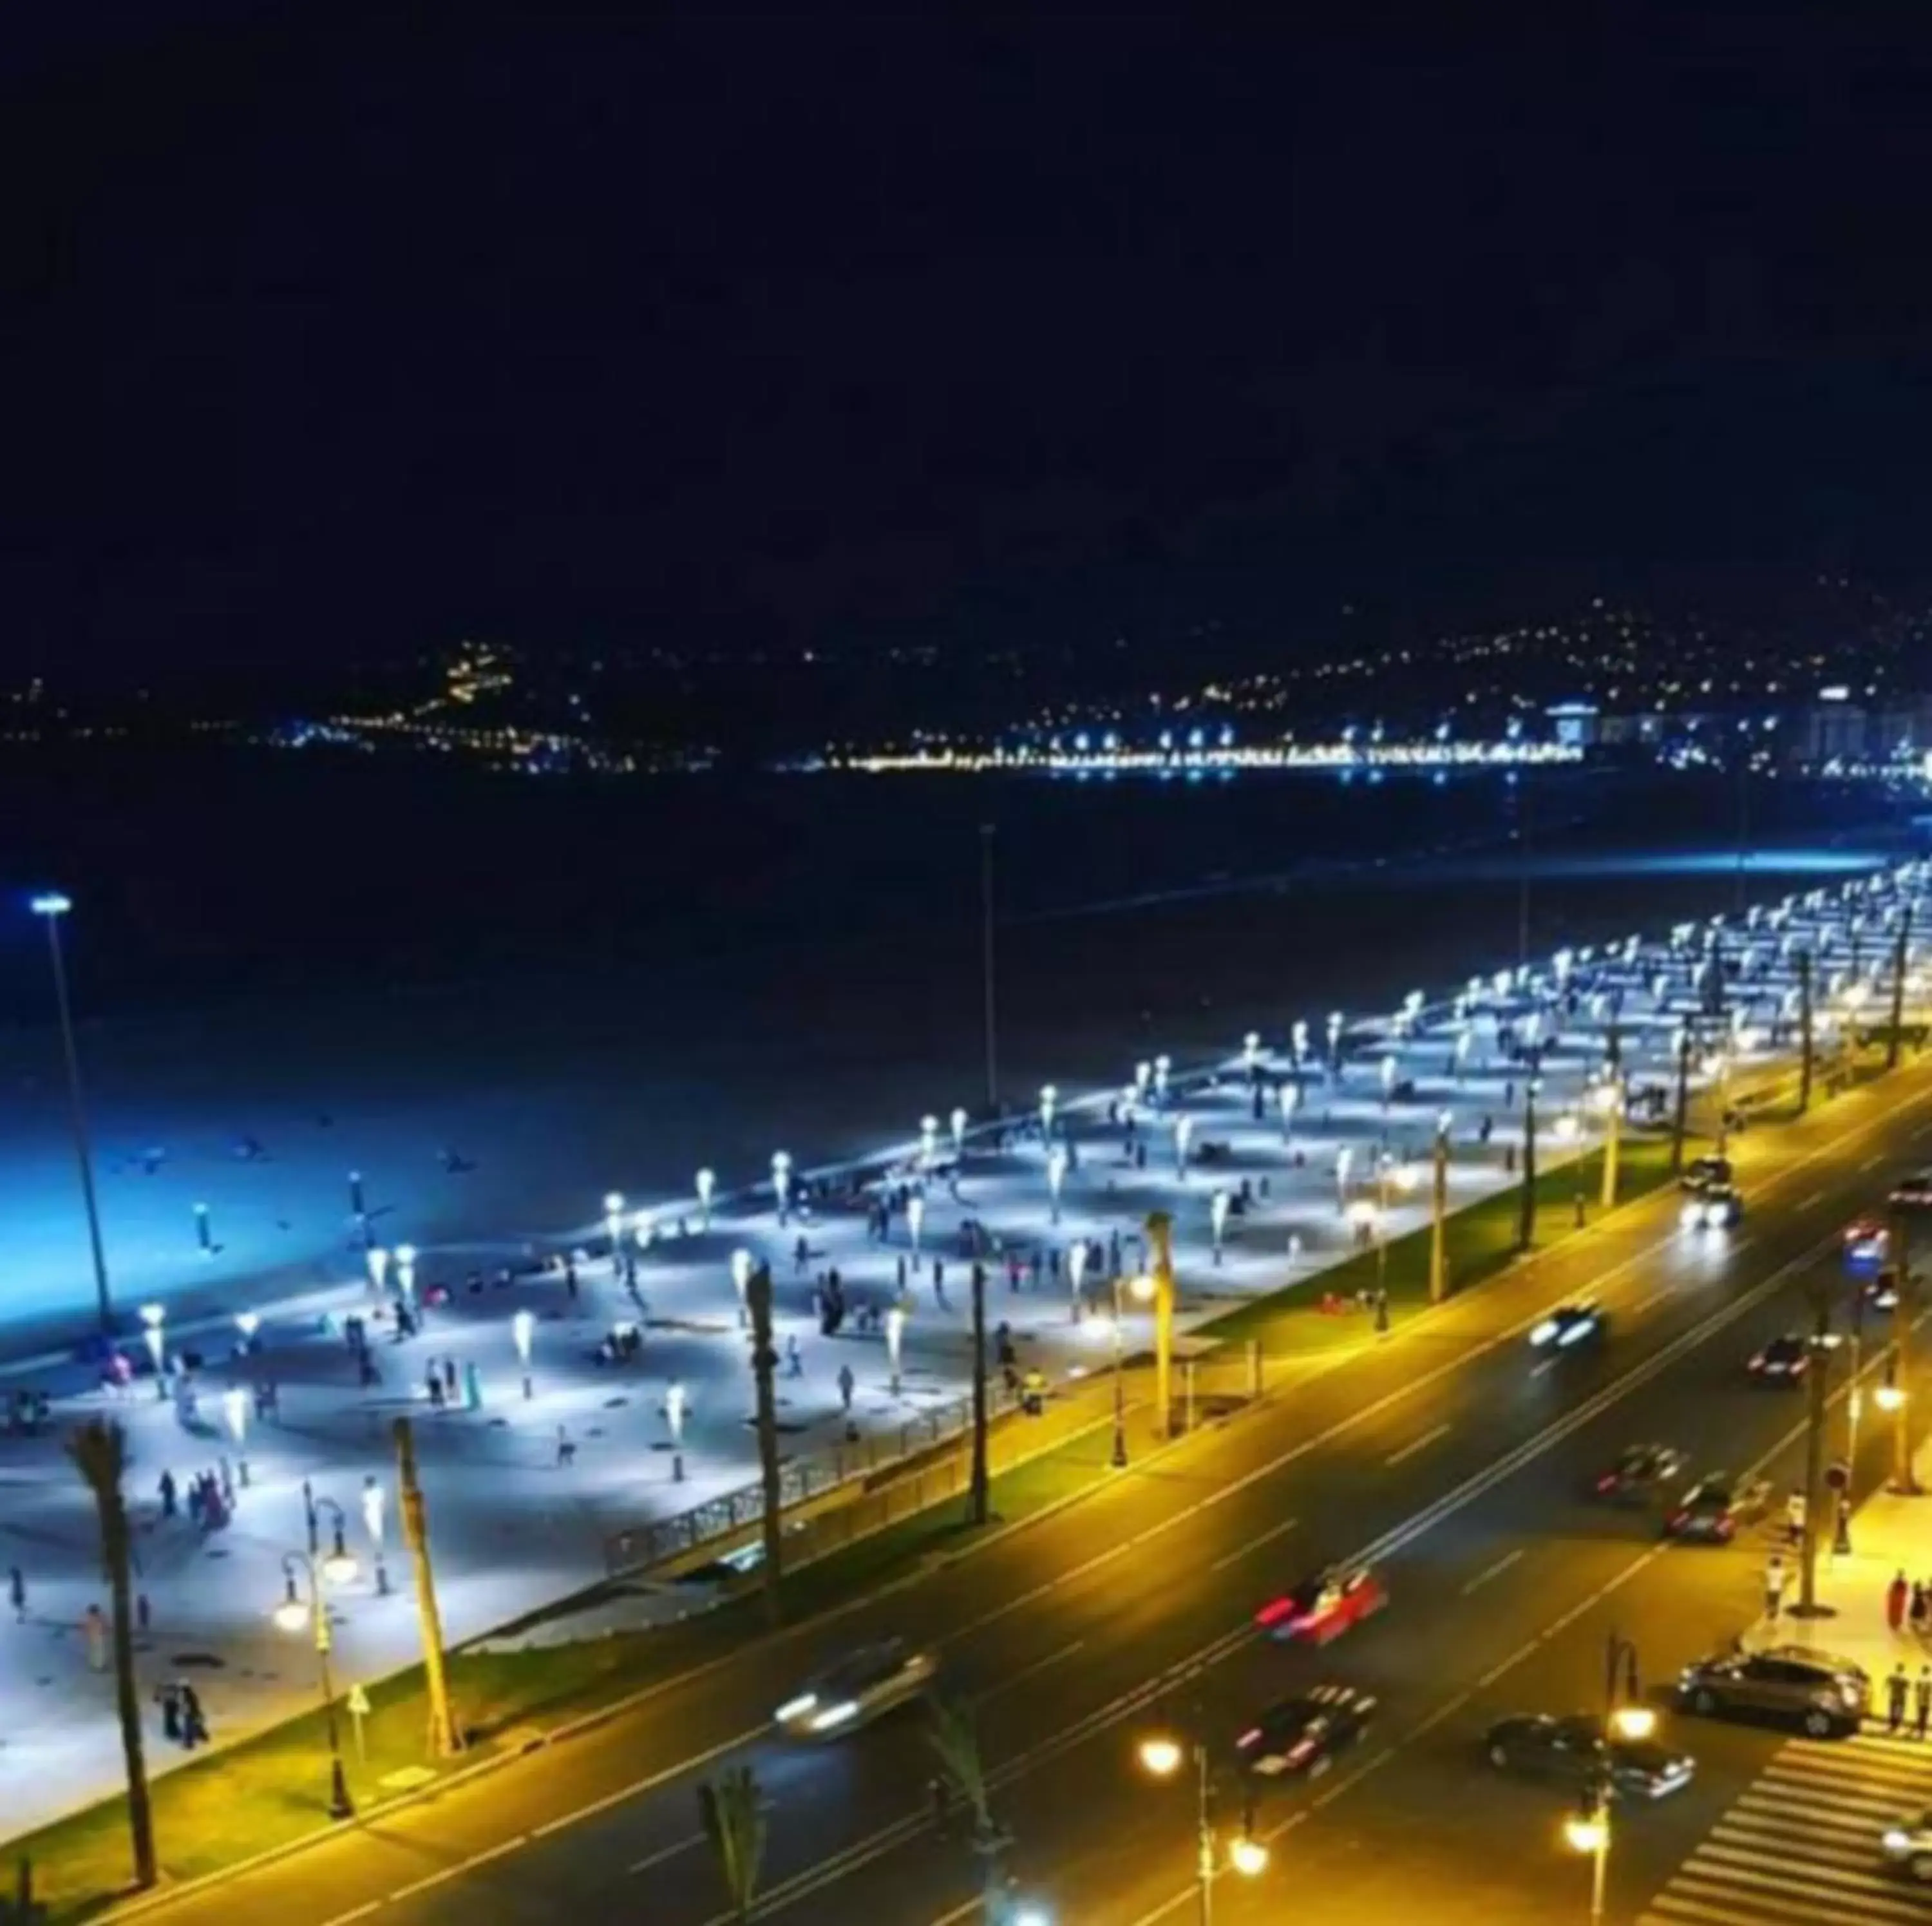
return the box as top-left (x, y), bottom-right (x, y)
top-left (6, 1134), bottom-right (1692, 1920)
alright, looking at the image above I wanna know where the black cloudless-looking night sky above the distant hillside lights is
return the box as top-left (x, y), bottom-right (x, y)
top-left (11, 0), bottom-right (1932, 674)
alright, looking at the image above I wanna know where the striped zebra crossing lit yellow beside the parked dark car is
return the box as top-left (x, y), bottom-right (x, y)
top-left (1638, 1731), bottom-right (1932, 1926)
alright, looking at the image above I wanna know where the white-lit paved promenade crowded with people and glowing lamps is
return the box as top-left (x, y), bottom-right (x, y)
top-left (0, 868), bottom-right (1926, 1831)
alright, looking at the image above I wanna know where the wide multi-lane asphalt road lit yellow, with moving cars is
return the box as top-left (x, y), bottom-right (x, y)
top-left (143, 1064), bottom-right (1932, 1926)
